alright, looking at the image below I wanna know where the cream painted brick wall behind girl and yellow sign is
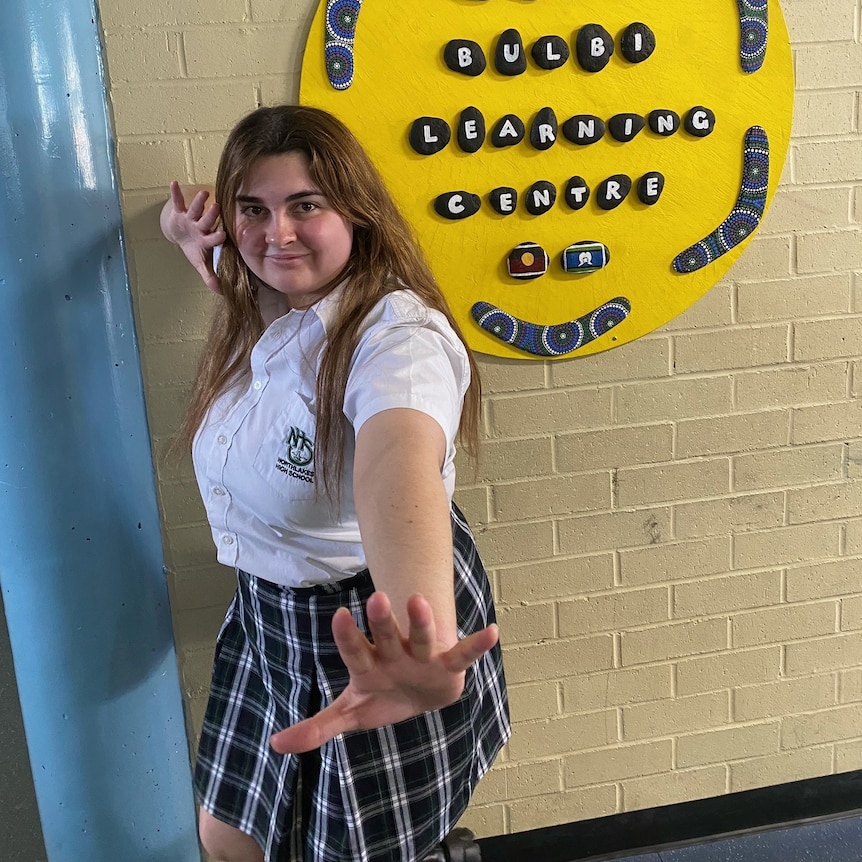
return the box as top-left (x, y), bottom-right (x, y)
top-left (100, 0), bottom-right (862, 848)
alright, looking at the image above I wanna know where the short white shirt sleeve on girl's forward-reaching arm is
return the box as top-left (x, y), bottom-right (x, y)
top-left (344, 292), bottom-right (470, 448)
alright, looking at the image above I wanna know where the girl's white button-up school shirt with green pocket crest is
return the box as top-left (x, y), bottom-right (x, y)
top-left (192, 288), bottom-right (470, 587)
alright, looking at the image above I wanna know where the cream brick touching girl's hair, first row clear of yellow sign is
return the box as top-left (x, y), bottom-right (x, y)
top-left (489, 389), bottom-right (611, 438)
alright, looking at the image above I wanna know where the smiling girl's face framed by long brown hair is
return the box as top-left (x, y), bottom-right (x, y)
top-left (236, 152), bottom-right (353, 309)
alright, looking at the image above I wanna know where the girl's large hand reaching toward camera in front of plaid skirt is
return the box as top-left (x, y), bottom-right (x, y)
top-left (270, 593), bottom-right (498, 754)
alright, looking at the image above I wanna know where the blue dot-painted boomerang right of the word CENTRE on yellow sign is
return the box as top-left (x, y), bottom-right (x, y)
top-left (673, 126), bottom-right (769, 273)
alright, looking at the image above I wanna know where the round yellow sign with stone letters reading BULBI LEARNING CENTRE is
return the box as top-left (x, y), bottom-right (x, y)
top-left (300, 0), bottom-right (793, 359)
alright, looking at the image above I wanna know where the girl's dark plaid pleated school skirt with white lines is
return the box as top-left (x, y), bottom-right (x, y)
top-left (195, 504), bottom-right (510, 862)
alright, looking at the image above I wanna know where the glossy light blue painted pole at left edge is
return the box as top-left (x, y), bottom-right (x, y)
top-left (0, 0), bottom-right (200, 862)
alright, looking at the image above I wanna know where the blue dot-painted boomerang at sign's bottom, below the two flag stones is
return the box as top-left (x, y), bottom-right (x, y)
top-left (470, 296), bottom-right (632, 356)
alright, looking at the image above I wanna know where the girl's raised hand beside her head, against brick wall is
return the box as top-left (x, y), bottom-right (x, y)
top-left (159, 180), bottom-right (226, 293)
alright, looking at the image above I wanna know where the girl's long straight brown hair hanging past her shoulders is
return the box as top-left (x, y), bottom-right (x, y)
top-left (179, 105), bottom-right (481, 501)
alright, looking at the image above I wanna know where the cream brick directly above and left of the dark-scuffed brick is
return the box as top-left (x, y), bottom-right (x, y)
top-left (492, 471), bottom-right (611, 521)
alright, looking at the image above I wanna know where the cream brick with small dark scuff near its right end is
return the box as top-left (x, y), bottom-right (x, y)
top-left (559, 508), bottom-right (671, 554)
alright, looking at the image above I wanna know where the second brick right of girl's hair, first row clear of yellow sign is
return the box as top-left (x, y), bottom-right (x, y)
top-left (616, 377), bottom-right (732, 427)
